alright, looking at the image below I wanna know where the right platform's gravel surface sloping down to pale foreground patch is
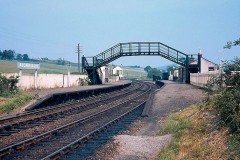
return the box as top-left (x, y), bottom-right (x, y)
top-left (109, 81), bottom-right (205, 160)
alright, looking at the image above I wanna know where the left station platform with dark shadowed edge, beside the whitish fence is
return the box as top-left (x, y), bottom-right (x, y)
top-left (25, 80), bottom-right (132, 110)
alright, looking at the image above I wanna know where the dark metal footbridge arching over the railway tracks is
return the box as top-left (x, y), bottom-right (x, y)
top-left (82, 42), bottom-right (195, 84)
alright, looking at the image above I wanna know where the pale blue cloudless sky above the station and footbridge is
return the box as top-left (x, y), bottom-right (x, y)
top-left (0, 0), bottom-right (240, 67)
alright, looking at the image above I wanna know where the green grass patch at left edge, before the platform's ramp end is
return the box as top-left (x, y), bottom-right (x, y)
top-left (0, 92), bottom-right (34, 113)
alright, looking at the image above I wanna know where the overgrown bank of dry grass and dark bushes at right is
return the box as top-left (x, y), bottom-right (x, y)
top-left (157, 58), bottom-right (240, 160)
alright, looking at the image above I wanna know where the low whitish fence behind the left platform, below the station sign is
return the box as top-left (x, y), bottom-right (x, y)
top-left (3, 73), bottom-right (88, 90)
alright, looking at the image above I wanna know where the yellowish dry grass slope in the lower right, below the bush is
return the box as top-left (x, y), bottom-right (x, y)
top-left (156, 100), bottom-right (240, 160)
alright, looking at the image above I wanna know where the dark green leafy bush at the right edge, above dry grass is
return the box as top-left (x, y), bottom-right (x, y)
top-left (209, 58), bottom-right (240, 134)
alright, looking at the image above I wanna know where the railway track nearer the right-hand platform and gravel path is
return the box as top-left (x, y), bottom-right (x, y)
top-left (0, 82), bottom-right (158, 159)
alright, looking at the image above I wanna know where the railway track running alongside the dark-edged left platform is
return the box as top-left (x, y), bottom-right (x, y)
top-left (0, 83), bottom-right (142, 137)
